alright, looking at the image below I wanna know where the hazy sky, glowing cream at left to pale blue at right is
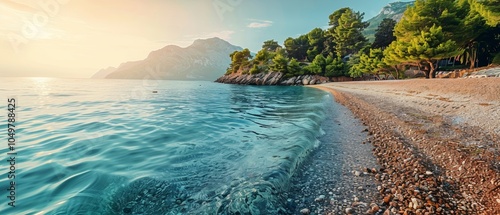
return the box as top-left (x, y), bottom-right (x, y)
top-left (0, 0), bottom-right (410, 78)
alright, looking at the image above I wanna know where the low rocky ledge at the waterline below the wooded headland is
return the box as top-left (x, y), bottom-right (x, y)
top-left (215, 72), bottom-right (333, 86)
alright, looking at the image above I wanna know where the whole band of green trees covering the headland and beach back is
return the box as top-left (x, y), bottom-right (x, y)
top-left (227, 0), bottom-right (500, 78)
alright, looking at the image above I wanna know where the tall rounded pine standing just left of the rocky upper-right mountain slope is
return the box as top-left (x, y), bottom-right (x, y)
top-left (329, 8), bottom-right (369, 57)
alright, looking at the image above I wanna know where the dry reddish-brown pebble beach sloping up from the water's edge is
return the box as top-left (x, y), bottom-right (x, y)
top-left (313, 78), bottom-right (500, 214)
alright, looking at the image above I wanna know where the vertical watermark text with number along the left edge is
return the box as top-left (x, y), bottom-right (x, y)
top-left (7, 98), bottom-right (17, 207)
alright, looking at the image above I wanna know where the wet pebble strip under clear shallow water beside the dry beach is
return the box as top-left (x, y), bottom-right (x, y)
top-left (285, 95), bottom-right (380, 215)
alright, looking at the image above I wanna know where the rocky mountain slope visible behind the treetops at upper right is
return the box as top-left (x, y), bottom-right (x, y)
top-left (363, 1), bottom-right (415, 41)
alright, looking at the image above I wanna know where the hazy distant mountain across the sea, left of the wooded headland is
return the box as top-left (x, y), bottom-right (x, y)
top-left (92, 37), bottom-right (242, 81)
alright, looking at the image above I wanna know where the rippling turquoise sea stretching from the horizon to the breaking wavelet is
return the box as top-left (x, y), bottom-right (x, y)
top-left (0, 78), bottom-right (332, 214)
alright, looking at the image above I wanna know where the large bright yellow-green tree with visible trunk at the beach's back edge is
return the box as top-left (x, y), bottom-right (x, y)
top-left (388, 0), bottom-right (470, 78)
